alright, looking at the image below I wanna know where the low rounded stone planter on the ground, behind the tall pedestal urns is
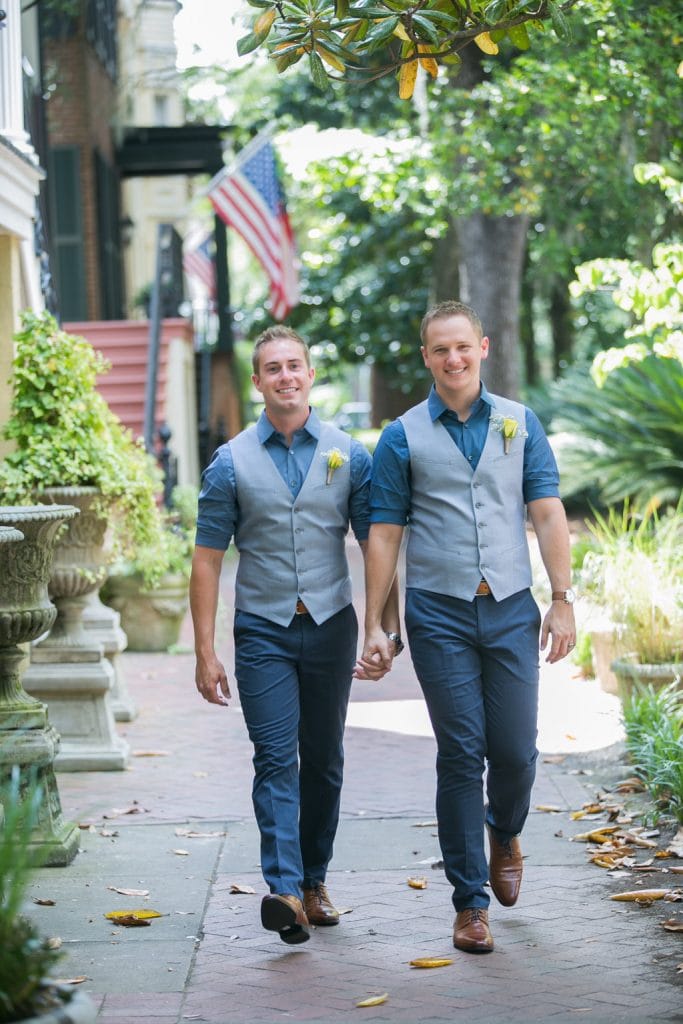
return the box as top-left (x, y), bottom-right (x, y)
top-left (105, 572), bottom-right (189, 651)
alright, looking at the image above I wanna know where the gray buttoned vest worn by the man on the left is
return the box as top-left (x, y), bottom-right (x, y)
top-left (228, 423), bottom-right (351, 626)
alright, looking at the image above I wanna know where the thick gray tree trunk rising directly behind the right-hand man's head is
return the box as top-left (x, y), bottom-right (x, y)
top-left (458, 213), bottom-right (528, 398)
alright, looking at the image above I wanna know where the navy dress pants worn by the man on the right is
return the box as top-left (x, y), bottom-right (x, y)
top-left (405, 589), bottom-right (541, 910)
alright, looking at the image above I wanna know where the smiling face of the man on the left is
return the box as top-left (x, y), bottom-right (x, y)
top-left (252, 338), bottom-right (315, 416)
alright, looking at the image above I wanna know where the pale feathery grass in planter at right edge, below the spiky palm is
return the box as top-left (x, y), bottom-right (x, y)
top-left (584, 504), bottom-right (683, 693)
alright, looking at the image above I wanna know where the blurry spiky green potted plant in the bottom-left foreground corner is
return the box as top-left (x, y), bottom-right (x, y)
top-left (0, 769), bottom-right (96, 1024)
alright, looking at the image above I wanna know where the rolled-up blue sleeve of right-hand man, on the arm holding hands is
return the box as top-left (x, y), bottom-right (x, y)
top-left (370, 420), bottom-right (411, 526)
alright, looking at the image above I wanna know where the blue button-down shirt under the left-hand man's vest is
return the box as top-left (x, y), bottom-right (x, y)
top-left (196, 410), bottom-right (372, 551)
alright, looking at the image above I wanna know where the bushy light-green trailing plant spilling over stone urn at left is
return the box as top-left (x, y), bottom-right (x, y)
top-left (0, 312), bottom-right (166, 585)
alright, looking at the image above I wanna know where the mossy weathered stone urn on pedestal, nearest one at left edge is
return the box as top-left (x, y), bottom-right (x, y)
top-left (0, 505), bottom-right (79, 865)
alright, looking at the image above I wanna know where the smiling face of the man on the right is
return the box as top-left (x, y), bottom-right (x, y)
top-left (421, 315), bottom-right (488, 404)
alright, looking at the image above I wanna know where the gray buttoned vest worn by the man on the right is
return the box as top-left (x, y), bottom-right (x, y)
top-left (400, 395), bottom-right (531, 601)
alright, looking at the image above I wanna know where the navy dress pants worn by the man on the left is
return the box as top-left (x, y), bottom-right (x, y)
top-left (234, 605), bottom-right (358, 896)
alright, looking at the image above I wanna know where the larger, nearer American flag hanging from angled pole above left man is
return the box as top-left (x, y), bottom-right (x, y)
top-left (208, 136), bottom-right (299, 321)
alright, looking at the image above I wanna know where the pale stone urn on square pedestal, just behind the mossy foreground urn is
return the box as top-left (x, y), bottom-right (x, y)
top-left (24, 486), bottom-right (128, 771)
